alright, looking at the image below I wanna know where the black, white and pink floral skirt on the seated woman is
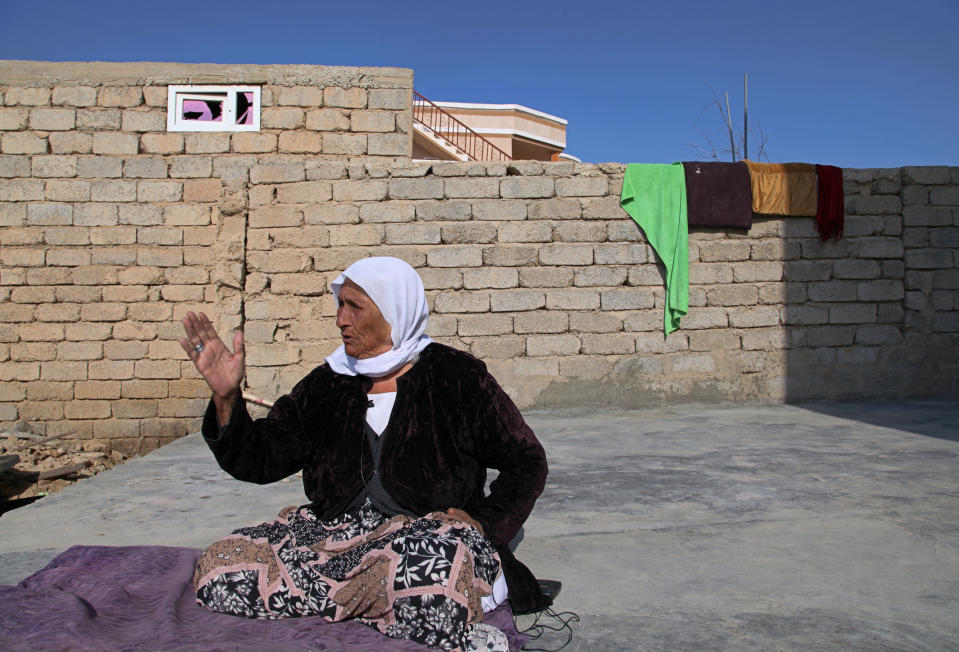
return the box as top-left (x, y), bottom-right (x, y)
top-left (194, 502), bottom-right (500, 650)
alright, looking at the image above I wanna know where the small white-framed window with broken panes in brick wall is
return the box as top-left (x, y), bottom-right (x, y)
top-left (167, 86), bottom-right (260, 131)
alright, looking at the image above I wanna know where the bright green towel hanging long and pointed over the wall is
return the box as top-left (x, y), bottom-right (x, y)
top-left (620, 163), bottom-right (689, 335)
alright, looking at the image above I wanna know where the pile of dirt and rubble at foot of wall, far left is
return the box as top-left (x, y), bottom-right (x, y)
top-left (0, 422), bottom-right (127, 513)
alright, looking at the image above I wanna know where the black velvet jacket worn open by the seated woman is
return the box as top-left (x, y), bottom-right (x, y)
top-left (203, 343), bottom-right (549, 613)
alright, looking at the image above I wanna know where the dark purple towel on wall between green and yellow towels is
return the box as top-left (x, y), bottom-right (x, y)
top-left (683, 161), bottom-right (753, 229)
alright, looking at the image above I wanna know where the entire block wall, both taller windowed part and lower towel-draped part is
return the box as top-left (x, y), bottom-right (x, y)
top-left (0, 62), bottom-right (959, 452)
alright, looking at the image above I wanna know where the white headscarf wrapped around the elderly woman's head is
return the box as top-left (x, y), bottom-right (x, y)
top-left (326, 256), bottom-right (433, 378)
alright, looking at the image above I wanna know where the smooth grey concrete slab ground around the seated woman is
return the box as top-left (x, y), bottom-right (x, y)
top-left (0, 400), bottom-right (959, 651)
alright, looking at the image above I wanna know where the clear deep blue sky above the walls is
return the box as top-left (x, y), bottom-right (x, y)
top-left (0, 0), bottom-right (959, 167)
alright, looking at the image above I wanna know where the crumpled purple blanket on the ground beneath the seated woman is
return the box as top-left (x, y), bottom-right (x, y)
top-left (0, 546), bottom-right (528, 652)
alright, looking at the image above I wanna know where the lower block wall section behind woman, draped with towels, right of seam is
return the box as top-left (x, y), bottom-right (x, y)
top-left (238, 162), bottom-right (959, 407)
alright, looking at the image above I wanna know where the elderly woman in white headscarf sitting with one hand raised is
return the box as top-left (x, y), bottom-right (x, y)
top-left (180, 258), bottom-right (548, 649)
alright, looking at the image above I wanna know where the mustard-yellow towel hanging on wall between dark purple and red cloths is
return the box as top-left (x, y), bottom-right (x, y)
top-left (746, 161), bottom-right (817, 217)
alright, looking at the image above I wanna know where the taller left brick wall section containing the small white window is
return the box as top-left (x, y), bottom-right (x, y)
top-left (0, 61), bottom-right (412, 451)
